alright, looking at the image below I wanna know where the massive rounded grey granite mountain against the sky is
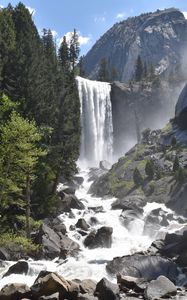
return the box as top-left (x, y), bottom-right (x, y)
top-left (83, 8), bottom-right (187, 81)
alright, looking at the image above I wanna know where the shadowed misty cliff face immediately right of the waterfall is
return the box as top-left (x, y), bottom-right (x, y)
top-left (111, 82), bottom-right (181, 157)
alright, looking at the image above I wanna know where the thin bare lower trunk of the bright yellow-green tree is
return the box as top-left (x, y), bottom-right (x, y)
top-left (25, 175), bottom-right (31, 239)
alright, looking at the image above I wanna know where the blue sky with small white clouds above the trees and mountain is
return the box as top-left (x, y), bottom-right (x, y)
top-left (0, 0), bottom-right (187, 54)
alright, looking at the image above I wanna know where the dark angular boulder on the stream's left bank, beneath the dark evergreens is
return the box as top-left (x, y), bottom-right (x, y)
top-left (58, 193), bottom-right (85, 214)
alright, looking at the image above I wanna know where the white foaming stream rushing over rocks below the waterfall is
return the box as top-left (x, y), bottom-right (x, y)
top-left (0, 169), bottom-right (184, 288)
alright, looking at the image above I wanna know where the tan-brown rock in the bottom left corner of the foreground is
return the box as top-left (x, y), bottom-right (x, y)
top-left (0, 283), bottom-right (30, 300)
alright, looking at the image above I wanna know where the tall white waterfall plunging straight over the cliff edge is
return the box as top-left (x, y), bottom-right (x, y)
top-left (76, 77), bottom-right (113, 165)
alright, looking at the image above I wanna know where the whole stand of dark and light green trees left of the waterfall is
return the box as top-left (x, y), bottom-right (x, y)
top-left (0, 3), bottom-right (80, 226)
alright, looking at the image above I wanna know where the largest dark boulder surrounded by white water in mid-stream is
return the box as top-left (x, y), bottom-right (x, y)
top-left (84, 226), bottom-right (113, 249)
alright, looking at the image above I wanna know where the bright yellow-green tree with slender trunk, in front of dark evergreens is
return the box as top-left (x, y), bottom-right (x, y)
top-left (0, 112), bottom-right (45, 238)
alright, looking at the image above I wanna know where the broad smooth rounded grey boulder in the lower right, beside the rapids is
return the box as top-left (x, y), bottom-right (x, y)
top-left (106, 254), bottom-right (179, 282)
